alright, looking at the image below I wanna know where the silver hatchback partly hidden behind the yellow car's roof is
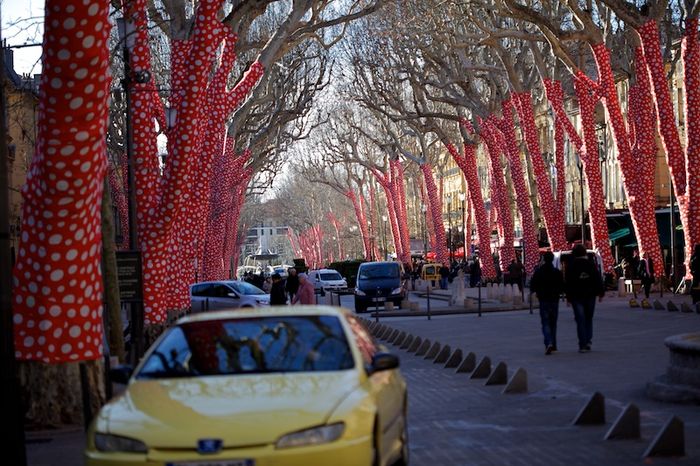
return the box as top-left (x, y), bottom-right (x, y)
top-left (190, 280), bottom-right (270, 312)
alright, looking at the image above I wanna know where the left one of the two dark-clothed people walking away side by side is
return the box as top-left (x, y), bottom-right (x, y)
top-left (530, 251), bottom-right (564, 354)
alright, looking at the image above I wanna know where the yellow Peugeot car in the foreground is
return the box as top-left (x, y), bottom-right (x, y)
top-left (85, 306), bottom-right (408, 466)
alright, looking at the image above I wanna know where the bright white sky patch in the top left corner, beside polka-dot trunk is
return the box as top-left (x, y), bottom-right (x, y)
top-left (0, 0), bottom-right (44, 74)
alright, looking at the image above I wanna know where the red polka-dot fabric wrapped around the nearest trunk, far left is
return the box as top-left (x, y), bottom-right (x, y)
top-left (13, 0), bottom-right (110, 363)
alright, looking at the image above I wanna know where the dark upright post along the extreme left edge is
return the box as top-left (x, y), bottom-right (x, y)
top-left (0, 37), bottom-right (27, 466)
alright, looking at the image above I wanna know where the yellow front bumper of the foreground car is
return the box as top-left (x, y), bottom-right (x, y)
top-left (85, 437), bottom-right (373, 466)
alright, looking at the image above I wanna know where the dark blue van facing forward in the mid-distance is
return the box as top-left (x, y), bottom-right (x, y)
top-left (355, 262), bottom-right (405, 312)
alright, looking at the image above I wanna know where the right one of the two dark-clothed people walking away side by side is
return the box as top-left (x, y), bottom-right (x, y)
top-left (564, 244), bottom-right (605, 353)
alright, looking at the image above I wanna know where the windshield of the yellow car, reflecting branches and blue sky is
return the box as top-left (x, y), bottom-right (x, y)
top-left (137, 316), bottom-right (355, 379)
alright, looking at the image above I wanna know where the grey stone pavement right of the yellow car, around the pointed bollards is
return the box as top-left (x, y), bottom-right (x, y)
top-left (383, 297), bottom-right (700, 466)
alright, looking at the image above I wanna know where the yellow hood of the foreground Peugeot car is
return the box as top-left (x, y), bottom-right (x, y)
top-left (97, 370), bottom-right (359, 448)
